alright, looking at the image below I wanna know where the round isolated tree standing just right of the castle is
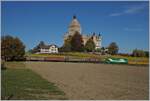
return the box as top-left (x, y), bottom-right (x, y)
top-left (108, 42), bottom-right (119, 55)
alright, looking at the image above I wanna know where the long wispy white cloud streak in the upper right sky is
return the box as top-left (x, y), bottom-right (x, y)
top-left (110, 5), bottom-right (146, 16)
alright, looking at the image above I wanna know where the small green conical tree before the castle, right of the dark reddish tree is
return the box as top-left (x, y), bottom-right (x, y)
top-left (84, 38), bottom-right (95, 52)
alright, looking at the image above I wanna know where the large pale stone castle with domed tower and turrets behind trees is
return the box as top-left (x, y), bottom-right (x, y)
top-left (64, 16), bottom-right (102, 49)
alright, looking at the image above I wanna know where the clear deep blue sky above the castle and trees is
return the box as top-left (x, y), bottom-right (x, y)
top-left (1, 1), bottom-right (149, 53)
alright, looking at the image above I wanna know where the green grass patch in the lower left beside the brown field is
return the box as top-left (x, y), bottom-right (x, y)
top-left (1, 63), bottom-right (67, 100)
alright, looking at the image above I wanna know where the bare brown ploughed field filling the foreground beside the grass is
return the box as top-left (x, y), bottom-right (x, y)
top-left (26, 62), bottom-right (149, 100)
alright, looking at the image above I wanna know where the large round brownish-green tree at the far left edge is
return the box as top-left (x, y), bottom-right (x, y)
top-left (1, 35), bottom-right (25, 61)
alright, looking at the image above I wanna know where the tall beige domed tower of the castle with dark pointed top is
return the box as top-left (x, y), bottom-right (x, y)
top-left (69, 16), bottom-right (81, 34)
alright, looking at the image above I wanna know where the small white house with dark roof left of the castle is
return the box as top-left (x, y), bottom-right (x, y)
top-left (40, 44), bottom-right (58, 53)
